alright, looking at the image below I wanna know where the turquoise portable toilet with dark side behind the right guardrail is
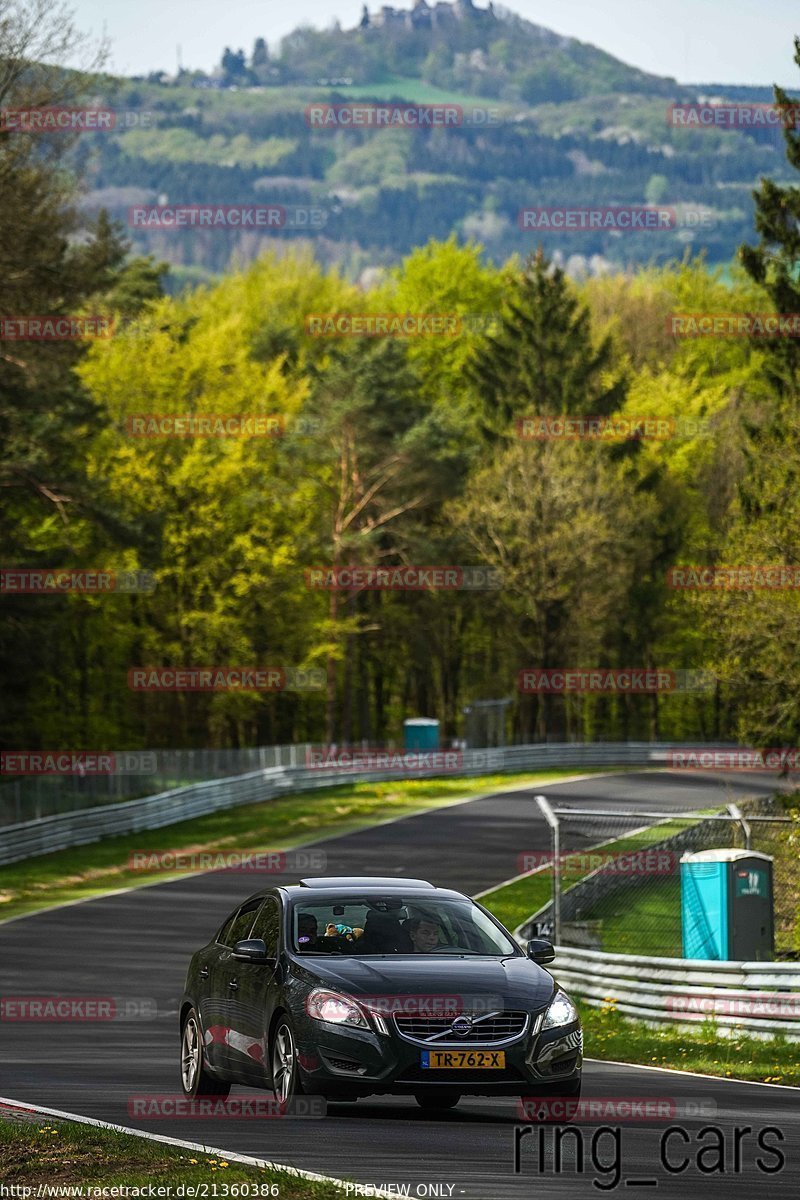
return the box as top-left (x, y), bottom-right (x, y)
top-left (680, 850), bottom-right (775, 962)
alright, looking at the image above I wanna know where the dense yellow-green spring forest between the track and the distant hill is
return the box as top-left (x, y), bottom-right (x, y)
top-left (0, 11), bottom-right (800, 749)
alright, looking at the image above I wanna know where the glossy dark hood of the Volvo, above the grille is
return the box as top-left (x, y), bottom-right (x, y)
top-left (293, 955), bottom-right (554, 1010)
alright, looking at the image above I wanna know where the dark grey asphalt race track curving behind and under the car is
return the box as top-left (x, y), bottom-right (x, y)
top-left (0, 773), bottom-right (800, 1200)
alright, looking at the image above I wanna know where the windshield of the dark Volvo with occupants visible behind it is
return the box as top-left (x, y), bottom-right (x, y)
top-left (291, 893), bottom-right (517, 958)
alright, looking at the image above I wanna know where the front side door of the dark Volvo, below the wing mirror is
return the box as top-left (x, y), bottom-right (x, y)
top-left (228, 896), bottom-right (281, 1085)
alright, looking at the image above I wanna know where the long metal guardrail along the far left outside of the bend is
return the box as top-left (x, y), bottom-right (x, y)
top-left (0, 742), bottom-right (702, 865)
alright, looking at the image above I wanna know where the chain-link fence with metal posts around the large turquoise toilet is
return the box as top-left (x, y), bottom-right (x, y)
top-left (522, 794), bottom-right (800, 959)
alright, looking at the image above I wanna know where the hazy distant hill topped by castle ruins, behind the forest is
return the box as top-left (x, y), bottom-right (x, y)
top-left (74, 0), bottom-right (787, 286)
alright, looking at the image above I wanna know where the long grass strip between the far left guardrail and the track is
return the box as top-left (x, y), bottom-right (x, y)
top-left (0, 768), bottom-right (608, 920)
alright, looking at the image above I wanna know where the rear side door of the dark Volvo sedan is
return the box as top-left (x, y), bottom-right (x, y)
top-left (200, 899), bottom-right (261, 1074)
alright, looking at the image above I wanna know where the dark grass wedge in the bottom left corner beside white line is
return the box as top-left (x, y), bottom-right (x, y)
top-left (0, 1117), bottom-right (343, 1200)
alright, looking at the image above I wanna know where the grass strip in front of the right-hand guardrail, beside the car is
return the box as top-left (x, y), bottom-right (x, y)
top-left (577, 1000), bottom-right (800, 1087)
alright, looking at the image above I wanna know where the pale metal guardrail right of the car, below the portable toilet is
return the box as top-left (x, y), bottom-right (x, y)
top-left (551, 946), bottom-right (800, 1042)
